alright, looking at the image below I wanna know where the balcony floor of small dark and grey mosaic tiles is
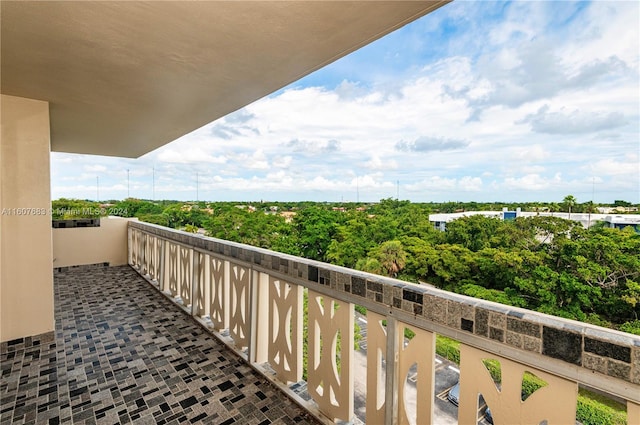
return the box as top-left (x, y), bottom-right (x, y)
top-left (0, 266), bottom-right (316, 425)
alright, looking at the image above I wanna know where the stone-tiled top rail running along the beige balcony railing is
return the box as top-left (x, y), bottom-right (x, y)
top-left (129, 221), bottom-right (640, 403)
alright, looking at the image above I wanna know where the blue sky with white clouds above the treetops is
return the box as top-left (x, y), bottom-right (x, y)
top-left (51, 1), bottom-right (640, 203)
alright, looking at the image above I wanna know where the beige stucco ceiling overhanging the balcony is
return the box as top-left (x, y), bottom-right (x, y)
top-left (0, 0), bottom-right (447, 157)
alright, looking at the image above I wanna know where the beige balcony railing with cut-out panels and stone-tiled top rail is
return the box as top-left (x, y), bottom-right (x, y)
top-left (128, 221), bottom-right (640, 424)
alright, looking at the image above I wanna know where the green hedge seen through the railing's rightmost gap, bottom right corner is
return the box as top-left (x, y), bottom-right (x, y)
top-left (576, 388), bottom-right (627, 425)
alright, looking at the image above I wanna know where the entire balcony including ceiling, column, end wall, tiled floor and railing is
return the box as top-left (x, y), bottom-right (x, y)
top-left (5, 1), bottom-right (640, 425)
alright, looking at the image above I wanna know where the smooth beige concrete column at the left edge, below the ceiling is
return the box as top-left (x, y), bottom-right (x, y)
top-left (0, 95), bottom-right (55, 342)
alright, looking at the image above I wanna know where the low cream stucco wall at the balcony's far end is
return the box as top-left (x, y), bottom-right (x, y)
top-left (53, 217), bottom-right (135, 267)
